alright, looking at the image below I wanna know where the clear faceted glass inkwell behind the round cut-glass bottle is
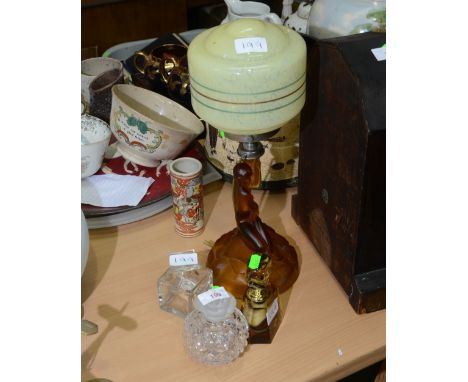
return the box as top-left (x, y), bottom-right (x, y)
top-left (158, 264), bottom-right (213, 318)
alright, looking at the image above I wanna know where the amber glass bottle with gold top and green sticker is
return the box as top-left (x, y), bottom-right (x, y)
top-left (242, 253), bottom-right (281, 344)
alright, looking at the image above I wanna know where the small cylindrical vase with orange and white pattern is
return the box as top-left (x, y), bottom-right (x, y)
top-left (169, 157), bottom-right (204, 237)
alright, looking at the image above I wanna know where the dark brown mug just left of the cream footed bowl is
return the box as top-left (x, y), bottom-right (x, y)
top-left (89, 69), bottom-right (124, 123)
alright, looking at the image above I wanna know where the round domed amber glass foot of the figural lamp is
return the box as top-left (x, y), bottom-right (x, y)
top-left (206, 223), bottom-right (299, 300)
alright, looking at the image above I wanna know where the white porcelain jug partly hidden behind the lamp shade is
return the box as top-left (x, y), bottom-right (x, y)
top-left (221, 0), bottom-right (282, 24)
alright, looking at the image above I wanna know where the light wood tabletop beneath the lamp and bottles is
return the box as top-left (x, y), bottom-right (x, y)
top-left (82, 181), bottom-right (385, 382)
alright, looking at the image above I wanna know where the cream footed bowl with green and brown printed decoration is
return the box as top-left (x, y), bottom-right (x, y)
top-left (110, 85), bottom-right (204, 167)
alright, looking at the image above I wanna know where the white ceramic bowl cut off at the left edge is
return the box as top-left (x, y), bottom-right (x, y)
top-left (81, 114), bottom-right (111, 179)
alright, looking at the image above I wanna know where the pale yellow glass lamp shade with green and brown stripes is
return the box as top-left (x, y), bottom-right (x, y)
top-left (187, 18), bottom-right (306, 136)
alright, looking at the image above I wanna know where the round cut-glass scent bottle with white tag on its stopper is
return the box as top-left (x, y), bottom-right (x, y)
top-left (184, 287), bottom-right (249, 365)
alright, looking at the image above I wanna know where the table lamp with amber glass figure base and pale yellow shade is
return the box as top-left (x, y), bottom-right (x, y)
top-left (187, 18), bottom-right (306, 299)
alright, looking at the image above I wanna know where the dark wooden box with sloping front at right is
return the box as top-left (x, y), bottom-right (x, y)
top-left (292, 33), bottom-right (386, 313)
